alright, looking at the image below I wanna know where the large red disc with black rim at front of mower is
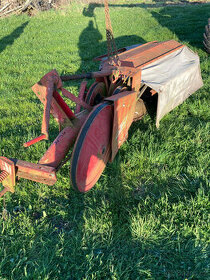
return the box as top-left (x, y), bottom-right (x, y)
top-left (70, 103), bottom-right (113, 192)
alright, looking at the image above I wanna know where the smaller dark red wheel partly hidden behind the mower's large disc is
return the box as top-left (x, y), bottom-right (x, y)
top-left (85, 82), bottom-right (106, 106)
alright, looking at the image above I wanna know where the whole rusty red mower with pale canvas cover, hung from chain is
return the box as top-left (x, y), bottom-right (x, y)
top-left (0, 0), bottom-right (202, 196)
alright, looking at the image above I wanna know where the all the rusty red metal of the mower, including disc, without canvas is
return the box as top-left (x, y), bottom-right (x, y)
top-left (0, 37), bottom-right (192, 197)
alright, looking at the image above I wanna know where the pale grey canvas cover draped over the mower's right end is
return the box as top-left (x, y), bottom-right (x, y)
top-left (141, 46), bottom-right (203, 127)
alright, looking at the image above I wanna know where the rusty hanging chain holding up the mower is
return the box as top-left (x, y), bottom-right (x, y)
top-left (104, 0), bottom-right (119, 66)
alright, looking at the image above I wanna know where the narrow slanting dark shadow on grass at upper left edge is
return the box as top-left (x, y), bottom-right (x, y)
top-left (0, 21), bottom-right (29, 53)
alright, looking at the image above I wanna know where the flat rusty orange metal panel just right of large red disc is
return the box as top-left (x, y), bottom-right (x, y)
top-left (105, 91), bottom-right (137, 161)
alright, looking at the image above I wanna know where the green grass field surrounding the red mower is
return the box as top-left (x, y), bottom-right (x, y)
top-left (0, 0), bottom-right (210, 280)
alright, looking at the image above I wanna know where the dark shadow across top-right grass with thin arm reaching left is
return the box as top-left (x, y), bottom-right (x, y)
top-left (83, 0), bottom-right (209, 48)
